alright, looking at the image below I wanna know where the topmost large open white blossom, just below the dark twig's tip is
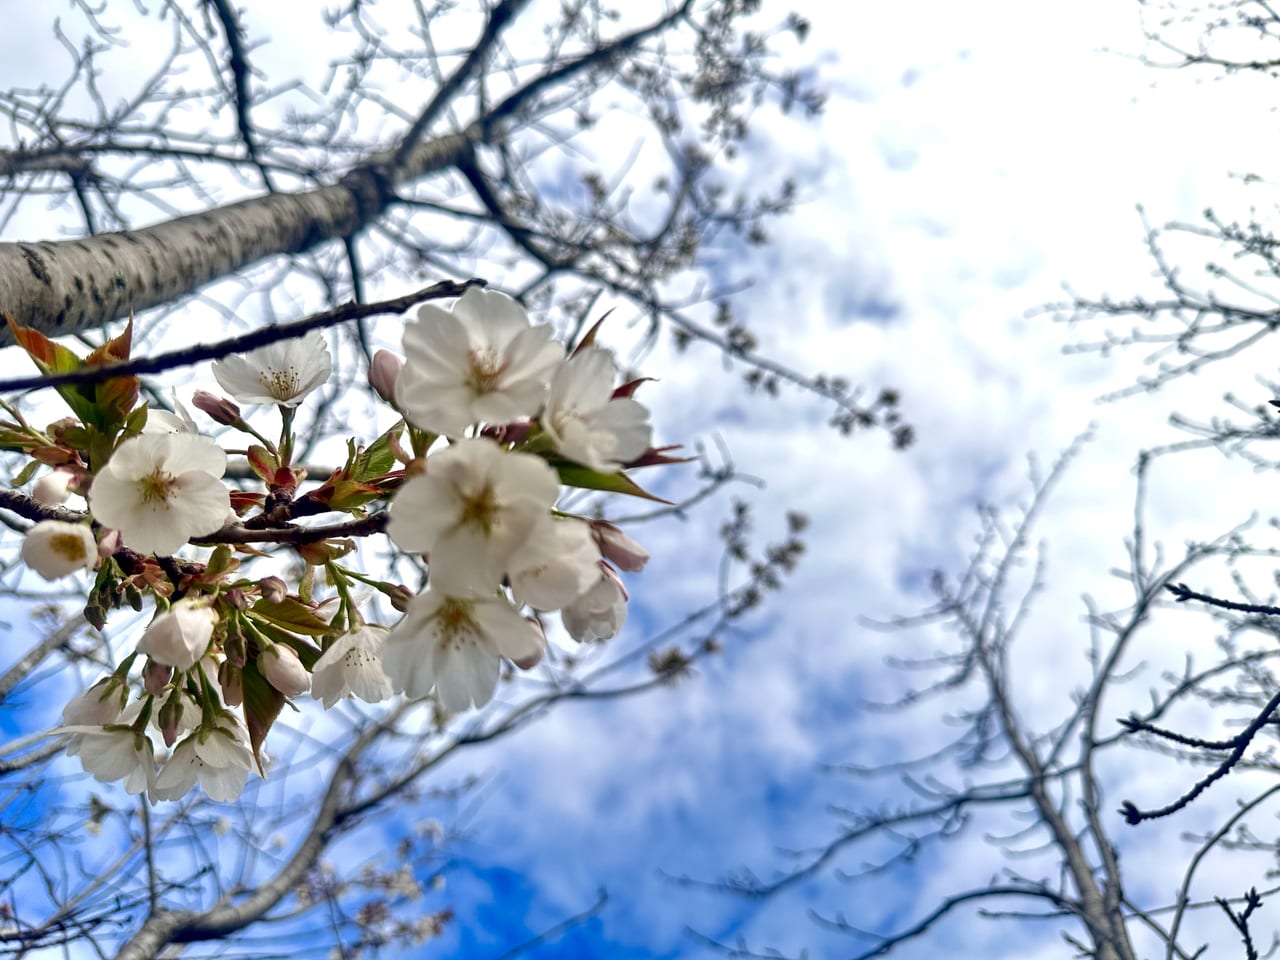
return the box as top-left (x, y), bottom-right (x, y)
top-left (396, 287), bottom-right (564, 436)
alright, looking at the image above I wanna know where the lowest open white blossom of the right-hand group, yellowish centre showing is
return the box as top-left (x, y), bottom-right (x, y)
top-left (383, 589), bottom-right (544, 713)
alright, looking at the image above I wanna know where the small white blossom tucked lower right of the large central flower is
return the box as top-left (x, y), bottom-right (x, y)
top-left (507, 517), bottom-right (600, 611)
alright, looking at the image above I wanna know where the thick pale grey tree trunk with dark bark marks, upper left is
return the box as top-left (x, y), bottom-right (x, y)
top-left (0, 133), bottom-right (468, 344)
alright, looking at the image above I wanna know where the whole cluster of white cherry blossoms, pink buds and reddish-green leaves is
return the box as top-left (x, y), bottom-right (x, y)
top-left (0, 287), bottom-right (677, 800)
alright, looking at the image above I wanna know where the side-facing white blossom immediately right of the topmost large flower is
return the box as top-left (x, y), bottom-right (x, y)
top-left (540, 347), bottom-right (652, 474)
